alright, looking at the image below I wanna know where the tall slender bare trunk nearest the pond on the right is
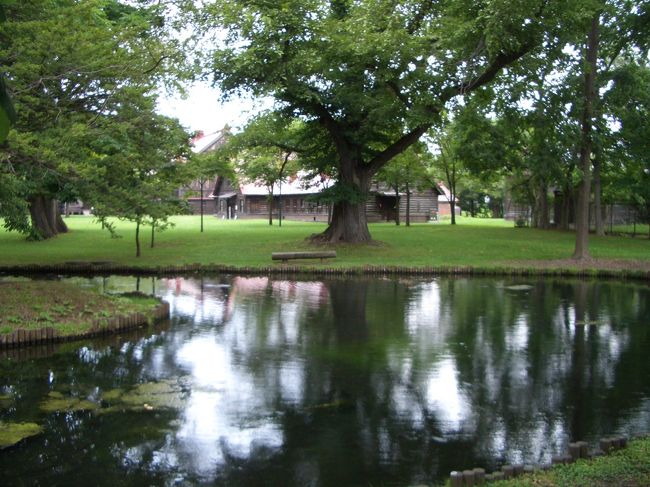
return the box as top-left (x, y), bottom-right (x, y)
top-left (573, 14), bottom-right (600, 260)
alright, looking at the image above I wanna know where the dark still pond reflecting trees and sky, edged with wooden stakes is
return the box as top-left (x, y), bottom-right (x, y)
top-left (0, 276), bottom-right (650, 486)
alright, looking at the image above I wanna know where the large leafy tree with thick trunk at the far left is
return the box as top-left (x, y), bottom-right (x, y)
top-left (0, 0), bottom-right (190, 238)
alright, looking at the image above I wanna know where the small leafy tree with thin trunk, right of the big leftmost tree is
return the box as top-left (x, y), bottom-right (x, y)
top-left (82, 88), bottom-right (191, 257)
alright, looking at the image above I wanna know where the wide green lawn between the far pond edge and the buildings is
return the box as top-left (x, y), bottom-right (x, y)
top-left (0, 216), bottom-right (650, 268)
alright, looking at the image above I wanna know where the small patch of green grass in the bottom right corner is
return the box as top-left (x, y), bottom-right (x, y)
top-left (466, 438), bottom-right (650, 487)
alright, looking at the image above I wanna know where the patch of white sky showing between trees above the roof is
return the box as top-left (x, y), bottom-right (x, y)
top-left (158, 82), bottom-right (272, 134)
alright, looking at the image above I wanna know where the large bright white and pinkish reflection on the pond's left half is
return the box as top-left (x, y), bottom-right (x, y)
top-left (158, 277), bottom-right (327, 476)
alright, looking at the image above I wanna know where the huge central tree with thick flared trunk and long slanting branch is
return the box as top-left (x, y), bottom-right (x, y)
top-left (202, 0), bottom-right (589, 242)
